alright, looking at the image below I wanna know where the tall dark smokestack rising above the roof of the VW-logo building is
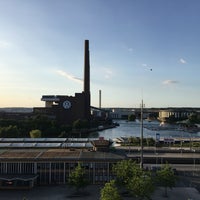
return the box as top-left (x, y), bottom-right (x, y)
top-left (84, 40), bottom-right (90, 94)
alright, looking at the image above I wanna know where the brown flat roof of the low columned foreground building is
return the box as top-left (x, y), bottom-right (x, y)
top-left (0, 148), bottom-right (125, 161)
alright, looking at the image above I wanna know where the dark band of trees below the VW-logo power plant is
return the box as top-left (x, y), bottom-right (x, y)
top-left (0, 115), bottom-right (92, 138)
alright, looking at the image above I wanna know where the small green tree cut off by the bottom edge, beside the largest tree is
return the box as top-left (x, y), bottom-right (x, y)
top-left (100, 180), bottom-right (122, 200)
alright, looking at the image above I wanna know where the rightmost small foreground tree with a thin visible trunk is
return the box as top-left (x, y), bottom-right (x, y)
top-left (156, 164), bottom-right (176, 197)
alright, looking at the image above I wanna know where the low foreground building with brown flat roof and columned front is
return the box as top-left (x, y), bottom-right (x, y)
top-left (0, 149), bottom-right (123, 189)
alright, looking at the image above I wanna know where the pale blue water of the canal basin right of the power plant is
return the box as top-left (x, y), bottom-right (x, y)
top-left (90, 120), bottom-right (200, 139)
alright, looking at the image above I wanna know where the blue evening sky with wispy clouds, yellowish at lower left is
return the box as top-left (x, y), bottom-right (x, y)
top-left (0, 0), bottom-right (200, 108)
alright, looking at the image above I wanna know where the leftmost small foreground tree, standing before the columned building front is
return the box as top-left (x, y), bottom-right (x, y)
top-left (68, 163), bottom-right (88, 192)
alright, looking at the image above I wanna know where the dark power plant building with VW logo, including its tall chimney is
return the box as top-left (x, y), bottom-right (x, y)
top-left (34, 40), bottom-right (91, 124)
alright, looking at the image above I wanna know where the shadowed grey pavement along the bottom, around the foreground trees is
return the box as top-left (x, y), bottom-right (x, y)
top-left (0, 185), bottom-right (200, 200)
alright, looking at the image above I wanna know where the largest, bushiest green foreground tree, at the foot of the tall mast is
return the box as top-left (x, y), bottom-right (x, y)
top-left (113, 160), bottom-right (154, 199)
